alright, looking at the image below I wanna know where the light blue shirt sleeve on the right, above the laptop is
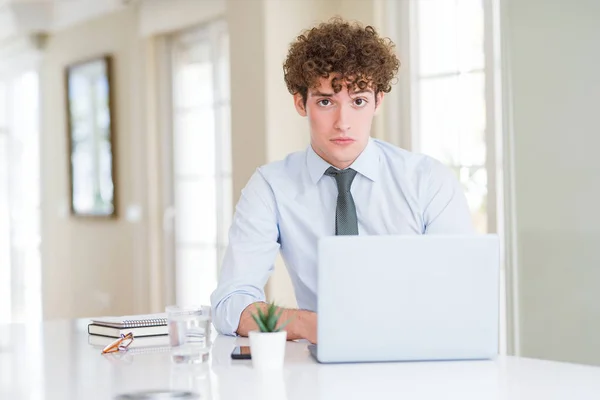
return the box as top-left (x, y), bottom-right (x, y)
top-left (423, 160), bottom-right (475, 235)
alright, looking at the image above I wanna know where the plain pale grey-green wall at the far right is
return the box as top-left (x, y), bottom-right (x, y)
top-left (503, 0), bottom-right (600, 365)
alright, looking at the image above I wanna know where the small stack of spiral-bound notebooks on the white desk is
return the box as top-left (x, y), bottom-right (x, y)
top-left (88, 313), bottom-right (169, 338)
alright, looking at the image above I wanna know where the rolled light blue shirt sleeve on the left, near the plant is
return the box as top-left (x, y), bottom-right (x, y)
top-left (211, 169), bottom-right (280, 335)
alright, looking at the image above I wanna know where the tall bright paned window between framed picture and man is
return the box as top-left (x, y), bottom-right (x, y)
top-left (171, 22), bottom-right (232, 304)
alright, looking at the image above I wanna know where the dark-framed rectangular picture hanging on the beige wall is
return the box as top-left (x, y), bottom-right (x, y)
top-left (65, 56), bottom-right (117, 217)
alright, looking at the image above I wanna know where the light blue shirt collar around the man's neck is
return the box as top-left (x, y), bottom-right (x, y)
top-left (306, 138), bottom-right (379, 184)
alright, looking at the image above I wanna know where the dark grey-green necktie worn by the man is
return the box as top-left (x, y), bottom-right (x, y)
top-left (325, 167), bottom-right (358, 235)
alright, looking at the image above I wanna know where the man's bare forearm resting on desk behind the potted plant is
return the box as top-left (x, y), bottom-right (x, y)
top-left (237, 302), bottom-right (317, 343)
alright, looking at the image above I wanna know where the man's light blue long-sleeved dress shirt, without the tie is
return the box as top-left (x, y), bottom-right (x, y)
top-left (211, 139), bottom-right (474, 335)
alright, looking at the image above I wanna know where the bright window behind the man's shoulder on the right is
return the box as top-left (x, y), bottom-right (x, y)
top-left (411, 0), bottom-right (490, 233)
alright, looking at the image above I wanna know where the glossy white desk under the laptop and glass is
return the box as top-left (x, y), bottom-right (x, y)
top-left (0, 320), bottom-right (600, 400)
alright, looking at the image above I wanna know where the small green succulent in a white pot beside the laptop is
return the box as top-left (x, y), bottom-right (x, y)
top-left (248, 303), bottom-right (290, 369)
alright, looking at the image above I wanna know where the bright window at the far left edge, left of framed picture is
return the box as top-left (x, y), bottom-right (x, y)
top-left (0, 70), bottom-right (42, 321)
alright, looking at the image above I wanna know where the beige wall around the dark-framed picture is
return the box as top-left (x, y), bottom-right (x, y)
top-left (40, 8), bottom-right (147, 318)
